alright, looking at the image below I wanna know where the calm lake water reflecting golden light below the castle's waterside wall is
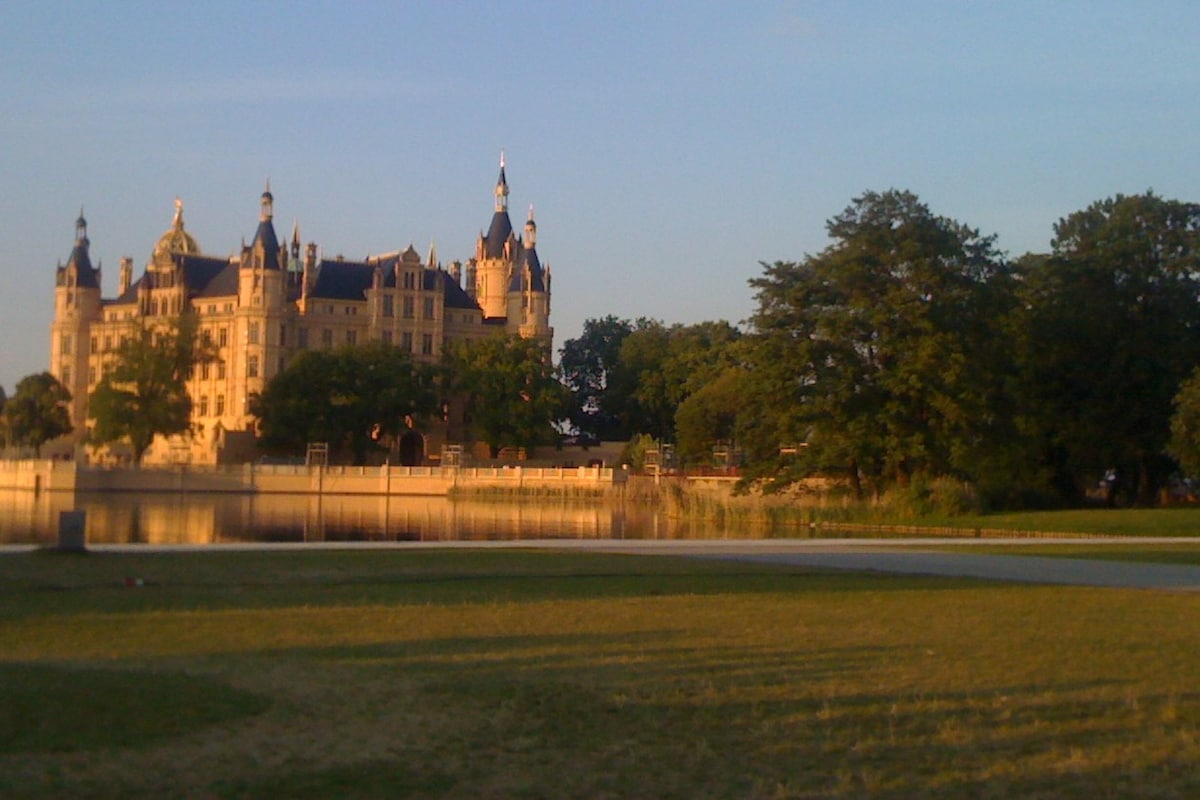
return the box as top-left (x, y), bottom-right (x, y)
top-left (0, 489), bottom-right (762, 545)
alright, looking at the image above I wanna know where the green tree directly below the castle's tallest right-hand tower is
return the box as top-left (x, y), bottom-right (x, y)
top-left (446, 336), bottom-right (568, 458)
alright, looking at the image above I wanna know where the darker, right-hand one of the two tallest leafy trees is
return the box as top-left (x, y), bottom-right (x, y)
top-left (1019, 192), bottom-right (1200, 503)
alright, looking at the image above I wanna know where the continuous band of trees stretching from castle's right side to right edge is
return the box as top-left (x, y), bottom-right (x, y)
top-left (560, 191), bottom-right (1200, 507)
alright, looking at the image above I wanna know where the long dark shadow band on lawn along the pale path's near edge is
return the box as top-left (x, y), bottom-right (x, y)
top-left (0, 552), bottom-right (998, 618)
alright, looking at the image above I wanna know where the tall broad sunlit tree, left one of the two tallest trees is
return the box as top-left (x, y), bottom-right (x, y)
top-left (738, 191), bottom-right (1010, 494)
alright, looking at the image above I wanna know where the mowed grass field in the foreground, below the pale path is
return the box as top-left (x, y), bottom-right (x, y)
top-left (0, 549), bottom-right (1200, 800)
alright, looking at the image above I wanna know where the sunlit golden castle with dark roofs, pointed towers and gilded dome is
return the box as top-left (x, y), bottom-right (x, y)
top-left (50, 156), bottom-right (553, 464)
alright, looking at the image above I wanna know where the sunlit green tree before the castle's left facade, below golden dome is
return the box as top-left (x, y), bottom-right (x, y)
top-left (88, 314), bottom-right (211, 463)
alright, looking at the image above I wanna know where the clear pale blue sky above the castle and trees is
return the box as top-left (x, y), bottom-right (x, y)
top-left (0, 0), bottom-right (1200, 393)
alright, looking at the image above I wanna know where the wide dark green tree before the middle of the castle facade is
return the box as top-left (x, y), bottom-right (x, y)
top-left (251, 344), bottom-right (437, 464)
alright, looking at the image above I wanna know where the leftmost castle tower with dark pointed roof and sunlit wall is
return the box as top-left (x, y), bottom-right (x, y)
top-left (50, 209), bottom-right (101, 435)
